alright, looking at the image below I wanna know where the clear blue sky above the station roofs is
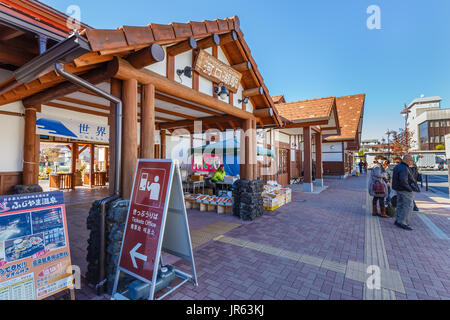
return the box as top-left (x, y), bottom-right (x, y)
top-left (44, 0), bottom-right (450, 139)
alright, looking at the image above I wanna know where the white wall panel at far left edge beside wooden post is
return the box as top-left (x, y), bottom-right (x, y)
top-left (0, 102), bottom-right (25, 172)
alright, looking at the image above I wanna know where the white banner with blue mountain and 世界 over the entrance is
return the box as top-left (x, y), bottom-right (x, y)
top-left (36, 113), bottom-right (109, 143)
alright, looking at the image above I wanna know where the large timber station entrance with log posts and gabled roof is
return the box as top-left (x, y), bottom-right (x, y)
top-left (0, 0), bottom-right (283, 199)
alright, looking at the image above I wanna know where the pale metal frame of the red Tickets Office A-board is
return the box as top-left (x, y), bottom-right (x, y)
top-left (111, 159), bottom-right (198, 300)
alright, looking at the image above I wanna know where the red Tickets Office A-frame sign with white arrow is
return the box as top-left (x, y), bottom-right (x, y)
top-left (112, 159), bottom-right (197, 300)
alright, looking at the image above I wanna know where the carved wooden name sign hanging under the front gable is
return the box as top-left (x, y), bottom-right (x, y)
top-left (194, 50), bottom-right (242, 93)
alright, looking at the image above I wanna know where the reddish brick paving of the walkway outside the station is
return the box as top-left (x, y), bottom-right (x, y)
top-left (60, 176), bottom-right (450, 300)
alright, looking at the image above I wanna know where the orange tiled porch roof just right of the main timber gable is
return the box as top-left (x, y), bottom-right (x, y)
top-left (275, 97), bottom-right (335, 122)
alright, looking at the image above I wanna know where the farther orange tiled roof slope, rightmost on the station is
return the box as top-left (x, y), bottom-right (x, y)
top-left (325, 94), bottom-right (366, 141)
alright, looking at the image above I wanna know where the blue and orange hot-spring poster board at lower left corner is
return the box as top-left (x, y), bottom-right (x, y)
top-left (0, 191), bottom-right (73, 300)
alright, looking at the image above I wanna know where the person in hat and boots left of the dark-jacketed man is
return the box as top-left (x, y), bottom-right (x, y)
top-left (369, 162), bottom-right (390, 218)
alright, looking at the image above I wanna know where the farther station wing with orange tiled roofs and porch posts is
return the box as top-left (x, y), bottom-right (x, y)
top-left (272, 94), bottom-right (365, 188)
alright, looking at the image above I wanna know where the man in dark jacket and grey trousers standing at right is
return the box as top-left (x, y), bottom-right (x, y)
top-left (392, 155), bottom-right (415, 230)
